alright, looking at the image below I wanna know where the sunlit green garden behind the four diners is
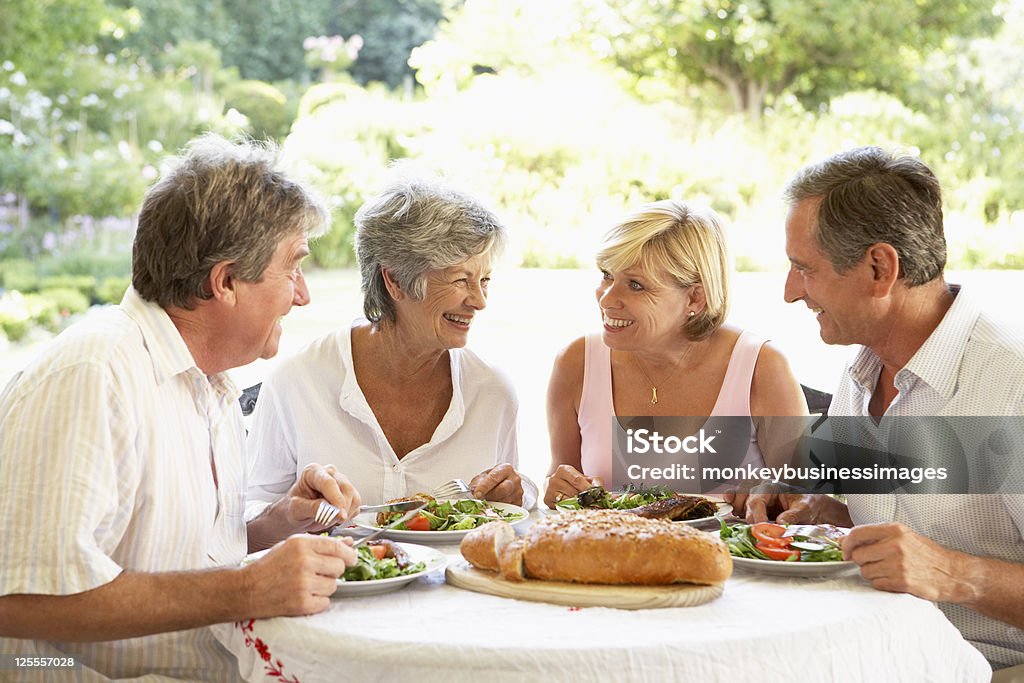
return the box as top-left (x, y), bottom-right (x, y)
top-left (0, 0), bottom-right (1024, 352)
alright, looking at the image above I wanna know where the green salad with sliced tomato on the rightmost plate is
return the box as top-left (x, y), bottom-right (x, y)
top-left (721, 520), bottom-right (843, 562)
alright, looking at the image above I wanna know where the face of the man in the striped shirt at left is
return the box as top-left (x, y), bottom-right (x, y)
top-left (232, 234), bottom-right (309, 366)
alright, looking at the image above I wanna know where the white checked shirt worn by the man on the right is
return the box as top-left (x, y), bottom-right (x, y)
top-left (828, 287), bottom-right (1024, 668)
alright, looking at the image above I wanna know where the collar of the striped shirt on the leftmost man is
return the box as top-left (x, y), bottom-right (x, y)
top-left (121, 287), bottom-right (242, 399)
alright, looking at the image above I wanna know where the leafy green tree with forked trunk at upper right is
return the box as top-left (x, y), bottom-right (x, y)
top-left (585, 0), bottom-right (999, 118)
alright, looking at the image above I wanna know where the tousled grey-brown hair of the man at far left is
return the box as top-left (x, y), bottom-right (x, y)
top-left (132, 133), bottom-right (330, 308)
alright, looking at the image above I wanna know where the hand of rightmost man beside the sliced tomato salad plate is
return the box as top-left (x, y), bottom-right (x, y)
top-left (840, 523), bottom-right (975, 603)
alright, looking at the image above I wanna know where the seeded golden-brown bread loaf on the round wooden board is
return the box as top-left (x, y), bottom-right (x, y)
top-left (460, 510), bottom-right (732, 586)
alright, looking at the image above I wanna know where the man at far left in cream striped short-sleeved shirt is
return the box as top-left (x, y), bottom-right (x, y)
top-left (0, 135), bottom-right (359, 681)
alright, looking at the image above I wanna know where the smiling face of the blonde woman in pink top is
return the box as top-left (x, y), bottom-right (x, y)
top-left (596, 266), bottom-right (690, 350)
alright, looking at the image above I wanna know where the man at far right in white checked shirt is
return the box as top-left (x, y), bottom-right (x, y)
top-left (746, 147), bottom-right (1024, 668)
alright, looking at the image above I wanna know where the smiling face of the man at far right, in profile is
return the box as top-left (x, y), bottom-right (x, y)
top-left (784, 198), bottom-right (873, 344)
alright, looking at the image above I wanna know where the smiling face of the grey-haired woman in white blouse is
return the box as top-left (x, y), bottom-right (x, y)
top-left (395, 254), bottom-right (490, 350)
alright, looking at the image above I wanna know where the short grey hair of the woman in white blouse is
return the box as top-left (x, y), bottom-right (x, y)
top-left (355, 175), bottom-right (507, 323)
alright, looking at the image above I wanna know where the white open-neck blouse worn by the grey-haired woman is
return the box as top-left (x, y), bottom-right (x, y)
top-left (247, 319), bottom-right (536, 511)
